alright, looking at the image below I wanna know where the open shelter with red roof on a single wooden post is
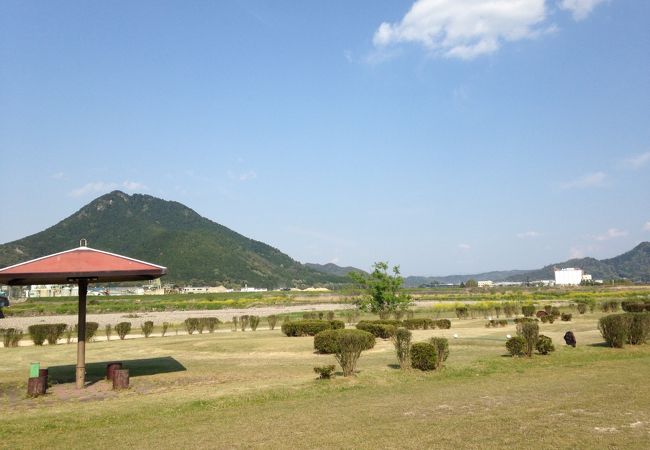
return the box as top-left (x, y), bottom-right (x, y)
top-left (0, 240), bottom-right (167, 389)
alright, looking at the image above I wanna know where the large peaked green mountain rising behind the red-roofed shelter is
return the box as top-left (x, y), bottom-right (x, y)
top-left (0, 191), bottom-right (347, 288)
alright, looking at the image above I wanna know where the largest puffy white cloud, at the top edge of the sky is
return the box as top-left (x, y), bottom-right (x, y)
top-left (373, 0), bottom-right (546, 59)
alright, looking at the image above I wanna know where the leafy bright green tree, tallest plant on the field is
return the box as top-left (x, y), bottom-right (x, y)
top-left (348, 262), bottom-right (412, 314)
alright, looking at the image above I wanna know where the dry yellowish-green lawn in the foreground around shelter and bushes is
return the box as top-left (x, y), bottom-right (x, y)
top-left (0, 314), bottom-right (650, 449)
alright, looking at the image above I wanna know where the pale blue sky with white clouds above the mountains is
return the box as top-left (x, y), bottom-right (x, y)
top-left (0, 0), bottom-right (650, 275)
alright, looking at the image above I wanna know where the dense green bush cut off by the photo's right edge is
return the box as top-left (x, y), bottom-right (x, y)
top-left (598, 312), bottom-right (650, 348)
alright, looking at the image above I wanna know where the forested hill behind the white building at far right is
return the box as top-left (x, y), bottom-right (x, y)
top-left (508, 242), bottom-right (650, 282)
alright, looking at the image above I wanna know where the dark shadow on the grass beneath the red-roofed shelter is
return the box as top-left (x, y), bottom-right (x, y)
top-left (48, 356), bottom-right (187, 384)
